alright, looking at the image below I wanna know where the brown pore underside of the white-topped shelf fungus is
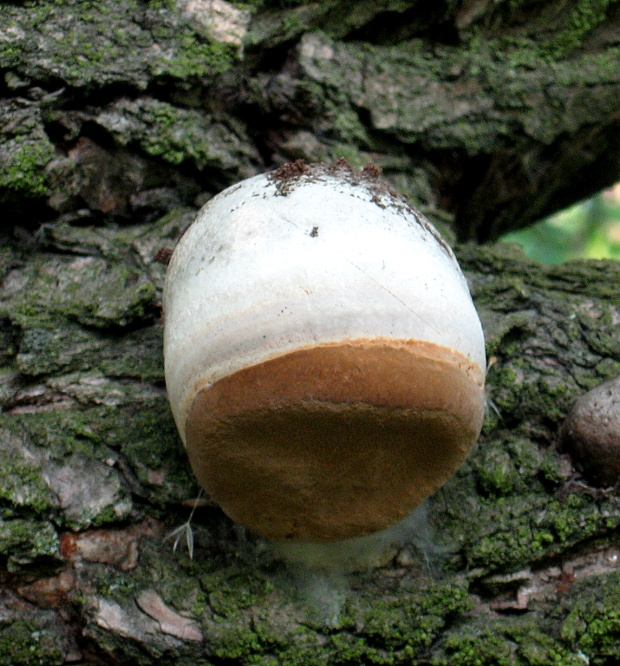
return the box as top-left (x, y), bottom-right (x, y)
top-left (186, 339), bottom-right (484, 542)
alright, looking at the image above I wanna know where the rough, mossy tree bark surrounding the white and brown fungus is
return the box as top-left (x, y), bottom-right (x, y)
top-left (0, 0), bottom-right (620, 666)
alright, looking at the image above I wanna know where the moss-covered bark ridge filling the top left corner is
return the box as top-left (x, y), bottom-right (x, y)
top-left (0, 0), bottom-right (238, 89)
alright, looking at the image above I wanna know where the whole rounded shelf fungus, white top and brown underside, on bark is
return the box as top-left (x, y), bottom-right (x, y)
top-left (164, 161), bottom-right (485, 543)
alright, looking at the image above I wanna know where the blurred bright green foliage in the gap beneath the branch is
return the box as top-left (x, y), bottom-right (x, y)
top-left (500, 183), bottom-right (620, 264)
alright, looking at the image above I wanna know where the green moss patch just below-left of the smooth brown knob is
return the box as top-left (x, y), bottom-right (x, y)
top-left (431, 440), bottom-right (620, 573)
